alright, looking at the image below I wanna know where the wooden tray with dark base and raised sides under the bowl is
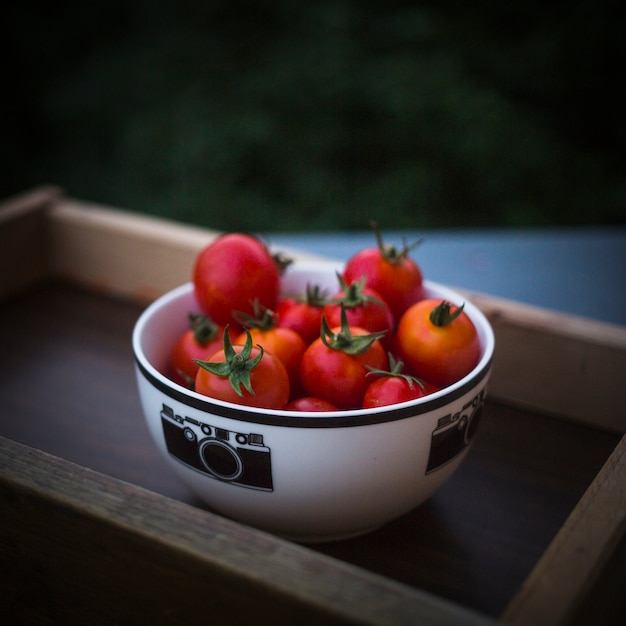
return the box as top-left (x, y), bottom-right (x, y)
top-left (0, 188), bottom-right (626, 626)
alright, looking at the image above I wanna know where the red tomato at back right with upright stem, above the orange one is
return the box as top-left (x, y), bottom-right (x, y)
top-left (343, 224), bottom-right (423, 321)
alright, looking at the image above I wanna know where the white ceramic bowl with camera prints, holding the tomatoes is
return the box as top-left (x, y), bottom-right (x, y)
top-left (132, 263), bottom-right (494, 542)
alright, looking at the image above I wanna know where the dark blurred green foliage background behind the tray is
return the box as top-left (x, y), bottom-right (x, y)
top-left (0, 0), bottom-right (626, 231)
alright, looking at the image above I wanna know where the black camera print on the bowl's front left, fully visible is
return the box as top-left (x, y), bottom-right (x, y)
top-left (161, 404), bottom-right (274, 491)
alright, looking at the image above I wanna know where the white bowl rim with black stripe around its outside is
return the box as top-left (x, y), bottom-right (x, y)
top-left (132, 262), bottom-right (495, 428)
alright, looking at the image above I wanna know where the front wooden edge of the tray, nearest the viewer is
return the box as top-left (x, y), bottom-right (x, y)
top-left (0, 437), bottom-right (496, 626)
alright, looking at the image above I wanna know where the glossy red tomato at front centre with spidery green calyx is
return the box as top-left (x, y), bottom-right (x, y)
top-left (300, 316), bottom-right (388, 409)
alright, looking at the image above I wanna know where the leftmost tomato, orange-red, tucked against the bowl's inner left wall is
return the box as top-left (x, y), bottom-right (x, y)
top-left (170, 313), bottom-right (224, 389)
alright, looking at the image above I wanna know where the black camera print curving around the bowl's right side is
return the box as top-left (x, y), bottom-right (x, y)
top-left (426, 387), bottom-right (486, 474)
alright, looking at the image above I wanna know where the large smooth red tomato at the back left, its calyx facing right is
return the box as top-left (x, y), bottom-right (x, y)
top-left (193, 233), bottom-right (281, 326)
